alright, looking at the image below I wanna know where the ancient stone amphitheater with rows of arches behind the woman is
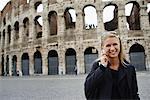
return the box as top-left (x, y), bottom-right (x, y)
top-left (0, 0), bottom-right (150, 76)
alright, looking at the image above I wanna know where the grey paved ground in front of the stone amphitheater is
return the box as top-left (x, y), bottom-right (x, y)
top-left (0, 71), bottom-right (150, 100)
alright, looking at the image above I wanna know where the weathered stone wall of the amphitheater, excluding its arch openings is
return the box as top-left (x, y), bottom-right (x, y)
top-left (0, 0), bottom-right (150, 75)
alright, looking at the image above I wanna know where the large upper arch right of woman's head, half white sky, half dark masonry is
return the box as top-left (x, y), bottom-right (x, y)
top-left (125, 1), bottom-right (141, 30)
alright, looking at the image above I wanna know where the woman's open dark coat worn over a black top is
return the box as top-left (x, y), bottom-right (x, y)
top-left (84, 61), bottom-right (140, 100)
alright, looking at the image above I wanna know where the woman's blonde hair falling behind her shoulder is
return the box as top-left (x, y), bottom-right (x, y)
top-left (101, 31), bottom-right (126, 64)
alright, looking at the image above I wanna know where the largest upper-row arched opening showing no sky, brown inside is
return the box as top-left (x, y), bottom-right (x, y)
top-left (48, 11), bottom-right (57, 35)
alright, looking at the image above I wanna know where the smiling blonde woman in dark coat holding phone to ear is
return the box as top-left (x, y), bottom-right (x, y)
top-left (84, 32), bottom-right (140, 100)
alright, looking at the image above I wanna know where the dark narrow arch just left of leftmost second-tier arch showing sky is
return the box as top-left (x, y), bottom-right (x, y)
top-left (22, 17), bottom-right (29, 41)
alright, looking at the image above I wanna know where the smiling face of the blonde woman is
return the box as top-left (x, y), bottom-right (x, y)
top-left (103, 37), bottom-right (120, 58)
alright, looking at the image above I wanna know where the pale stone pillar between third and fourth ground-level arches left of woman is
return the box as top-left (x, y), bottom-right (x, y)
top-left (42, 49), bottom-right (48, 75)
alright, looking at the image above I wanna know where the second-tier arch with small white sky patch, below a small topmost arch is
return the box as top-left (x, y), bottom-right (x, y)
top-left (34, 16), bottom-right (43, 39)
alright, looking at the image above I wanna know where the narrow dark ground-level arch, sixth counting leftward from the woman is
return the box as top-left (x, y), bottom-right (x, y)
top-left (12, 55), bottom-right (17, 76)
